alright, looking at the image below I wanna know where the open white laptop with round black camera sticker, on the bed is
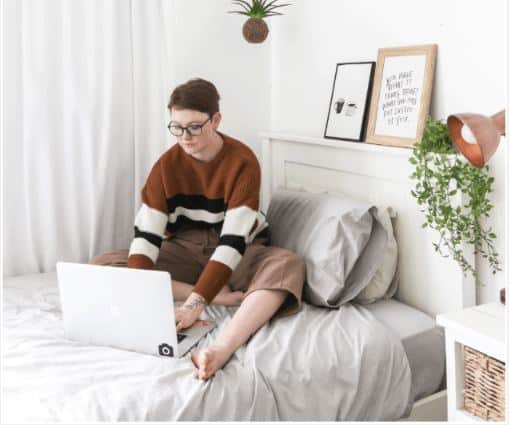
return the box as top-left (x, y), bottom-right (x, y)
top-left (57, 261), bottom-right (215, 357)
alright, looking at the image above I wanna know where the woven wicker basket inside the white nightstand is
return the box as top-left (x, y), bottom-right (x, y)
top-left (464, 346), bottom-right (505, 421)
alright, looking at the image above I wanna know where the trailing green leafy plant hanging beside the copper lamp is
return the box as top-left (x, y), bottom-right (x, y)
top-left (410, 117), bottom-right (501, 284)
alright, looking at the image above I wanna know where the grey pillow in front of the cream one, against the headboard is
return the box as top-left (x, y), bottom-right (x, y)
top-left (267, 189), bottom-right (388, 307)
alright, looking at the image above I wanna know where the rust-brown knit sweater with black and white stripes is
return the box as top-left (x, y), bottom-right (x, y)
top-left (127, 133), bottom-right (268, 303)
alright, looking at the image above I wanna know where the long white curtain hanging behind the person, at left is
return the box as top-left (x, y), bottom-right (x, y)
top-left (2, 0), bottom-right (175, 276)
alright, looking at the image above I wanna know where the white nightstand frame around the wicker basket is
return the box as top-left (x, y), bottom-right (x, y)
top-left (437, 302), bottom-right (506, 422)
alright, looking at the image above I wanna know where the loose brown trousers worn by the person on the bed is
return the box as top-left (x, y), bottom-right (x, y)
top-left (90, 226), bottom-right (305, 317)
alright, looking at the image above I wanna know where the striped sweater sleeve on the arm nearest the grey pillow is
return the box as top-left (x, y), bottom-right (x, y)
top-left (193, 160), bottom-right (266, 303)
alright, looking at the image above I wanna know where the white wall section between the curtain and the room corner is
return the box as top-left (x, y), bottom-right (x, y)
top-left (174, 0), bottom-right (271, 158)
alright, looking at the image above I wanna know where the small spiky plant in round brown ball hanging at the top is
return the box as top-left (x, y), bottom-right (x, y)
top-left (228, 0), bottom-right (290, 43)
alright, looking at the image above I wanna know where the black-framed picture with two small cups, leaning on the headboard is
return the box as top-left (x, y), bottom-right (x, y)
top-left (324, 62), bottom-right (375, 142)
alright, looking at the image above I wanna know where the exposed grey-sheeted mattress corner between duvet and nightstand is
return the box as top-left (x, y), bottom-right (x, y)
top-left (365, 299), bottom-right (445, 400)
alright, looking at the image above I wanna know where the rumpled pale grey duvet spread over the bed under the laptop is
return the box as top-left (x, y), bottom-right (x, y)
top-left (2, 273), bottom-right (413, 422)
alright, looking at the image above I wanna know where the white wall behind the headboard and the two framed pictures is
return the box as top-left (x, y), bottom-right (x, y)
top-left (270, 0), bottom-right (507, 303)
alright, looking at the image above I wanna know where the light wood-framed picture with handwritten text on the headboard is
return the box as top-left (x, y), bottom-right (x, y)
top-left (366, 44), bottom-right (437, 147)
